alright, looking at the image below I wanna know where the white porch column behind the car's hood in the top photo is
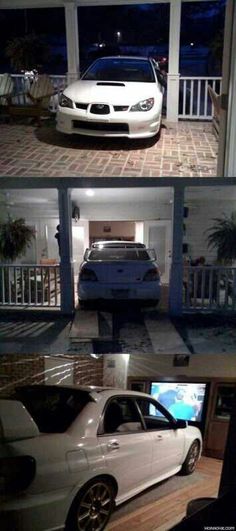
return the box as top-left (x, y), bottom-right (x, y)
top-left (64, 0), bottom-right (80, 84)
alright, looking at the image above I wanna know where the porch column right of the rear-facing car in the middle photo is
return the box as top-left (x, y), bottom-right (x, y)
top-left (169, 185), bottom-right (184, 316)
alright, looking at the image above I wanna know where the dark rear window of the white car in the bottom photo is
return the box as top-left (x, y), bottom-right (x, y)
top-left (13, 385), bottom-right (92, 433)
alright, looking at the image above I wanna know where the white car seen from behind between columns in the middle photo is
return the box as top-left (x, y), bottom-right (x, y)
top-left (78, 241), bottom-right (161, 306)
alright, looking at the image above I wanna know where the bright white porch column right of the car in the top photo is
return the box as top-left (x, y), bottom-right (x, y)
top-left (167, 0), bottom-right (181, 122)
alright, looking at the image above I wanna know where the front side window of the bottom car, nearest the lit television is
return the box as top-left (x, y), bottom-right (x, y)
top-left (137, 398), bottom-right (173, 430)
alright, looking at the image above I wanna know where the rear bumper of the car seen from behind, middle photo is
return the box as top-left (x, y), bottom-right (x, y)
top-left (78, 281), bottom-right (161, 301)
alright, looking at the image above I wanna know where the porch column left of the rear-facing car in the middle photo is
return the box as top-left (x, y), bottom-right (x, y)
top-left (58, 188), bottom-right (74, 315)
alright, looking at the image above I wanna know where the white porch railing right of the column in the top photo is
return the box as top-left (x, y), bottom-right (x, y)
top-left (179, 77), bottom-right (222, 120)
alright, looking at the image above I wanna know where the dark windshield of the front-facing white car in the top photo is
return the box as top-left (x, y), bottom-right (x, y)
top-left (82, 57), bottom-right (155, 83)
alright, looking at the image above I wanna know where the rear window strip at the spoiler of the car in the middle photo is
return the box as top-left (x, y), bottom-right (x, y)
top-left (85, 247), bottom-right (155, 262)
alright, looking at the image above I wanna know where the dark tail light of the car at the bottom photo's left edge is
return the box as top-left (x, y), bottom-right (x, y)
top-left (0, 455), bottom-right (36, 495)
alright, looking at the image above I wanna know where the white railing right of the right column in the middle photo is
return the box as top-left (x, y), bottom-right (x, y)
top-left (183, 266), bottom-right (236, 312)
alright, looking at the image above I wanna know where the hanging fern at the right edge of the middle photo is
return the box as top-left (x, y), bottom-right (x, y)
top-left (206, 212), bottom-right (236, 263)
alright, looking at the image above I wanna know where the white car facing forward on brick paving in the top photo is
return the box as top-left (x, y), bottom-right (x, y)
top-left (56, 57), bottom-right (164, 138)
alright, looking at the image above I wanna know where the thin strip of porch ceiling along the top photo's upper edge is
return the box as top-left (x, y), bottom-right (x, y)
top-left (0, 0), bottom-right (218, 9)
